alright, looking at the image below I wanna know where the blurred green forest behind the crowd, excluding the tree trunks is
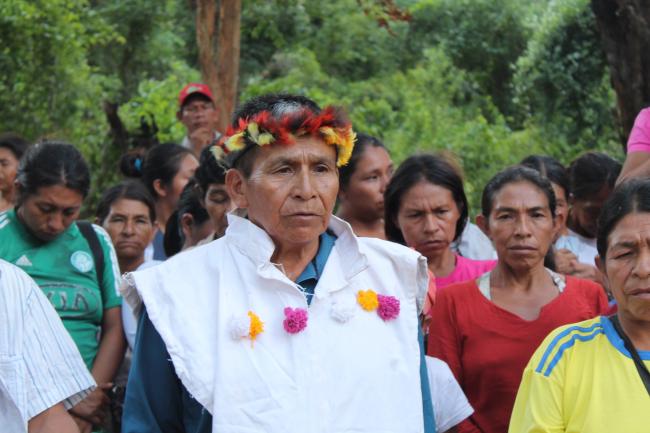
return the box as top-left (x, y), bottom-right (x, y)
top-left (0, 0), bottom-right (636, 214)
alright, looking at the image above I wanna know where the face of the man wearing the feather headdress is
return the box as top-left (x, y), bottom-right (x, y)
top-left (226, 137), bottom-right (339, 246)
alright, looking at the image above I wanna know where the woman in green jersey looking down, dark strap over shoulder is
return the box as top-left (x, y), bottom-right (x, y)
top-left (0, 142), bottom-right (126, 432)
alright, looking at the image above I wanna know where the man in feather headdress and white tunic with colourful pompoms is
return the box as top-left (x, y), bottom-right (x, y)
top-left (123, 95), bottom-right (435, 433)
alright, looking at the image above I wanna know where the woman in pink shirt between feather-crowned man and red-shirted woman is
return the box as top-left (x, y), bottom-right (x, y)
top-left (385, 154), bottom-right (496, 315)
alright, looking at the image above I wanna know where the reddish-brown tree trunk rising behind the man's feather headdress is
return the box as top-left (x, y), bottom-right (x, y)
top-left (196, 0), bottom-right (241, 131)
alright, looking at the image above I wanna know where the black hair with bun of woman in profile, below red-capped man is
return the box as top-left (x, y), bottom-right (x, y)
top-left (120, 143), bottom-right (192, 197)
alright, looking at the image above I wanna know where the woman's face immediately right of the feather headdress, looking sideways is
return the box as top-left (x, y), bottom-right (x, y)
top-left (339, 146), bottom-right (393, 221)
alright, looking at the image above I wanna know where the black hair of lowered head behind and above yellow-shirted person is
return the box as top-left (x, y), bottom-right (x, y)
top-left (569, 152), bottom-right (622, 200)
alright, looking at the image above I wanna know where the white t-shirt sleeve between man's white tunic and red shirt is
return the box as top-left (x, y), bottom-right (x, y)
top-left (426, 356), bottom-right (474, 432)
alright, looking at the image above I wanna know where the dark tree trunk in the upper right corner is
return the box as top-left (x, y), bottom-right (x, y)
top-left (591, 0), bottom-right (650, 152)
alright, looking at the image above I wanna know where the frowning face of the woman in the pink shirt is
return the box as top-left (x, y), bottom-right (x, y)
top-left (397, 180), bottom-right (460, 259)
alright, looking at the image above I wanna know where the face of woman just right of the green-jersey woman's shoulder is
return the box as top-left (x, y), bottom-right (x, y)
top-left (101, 198), bottom-right (154, 262)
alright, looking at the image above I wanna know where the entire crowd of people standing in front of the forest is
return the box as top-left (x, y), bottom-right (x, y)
top-left (0, 83), bottom-right (650, 433)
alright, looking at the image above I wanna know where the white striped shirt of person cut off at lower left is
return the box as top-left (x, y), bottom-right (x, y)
top-left (0, 260), bottom-right (95, 431)
